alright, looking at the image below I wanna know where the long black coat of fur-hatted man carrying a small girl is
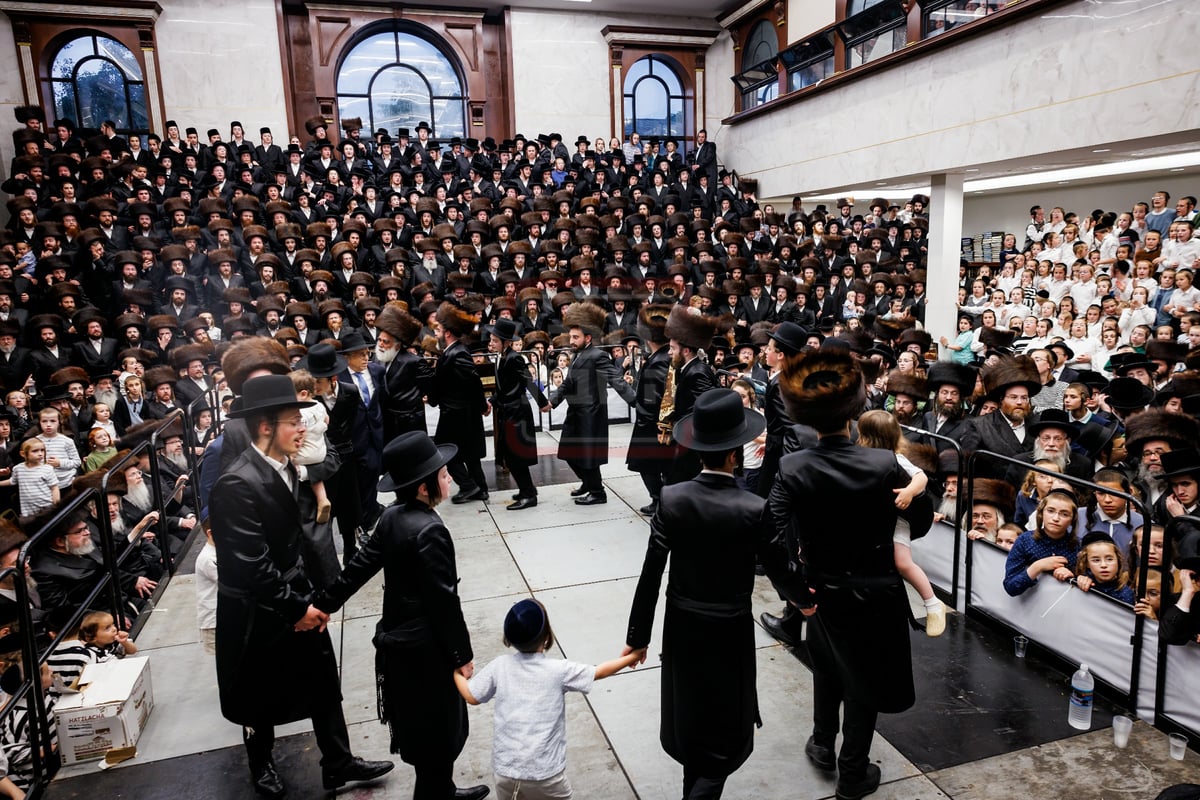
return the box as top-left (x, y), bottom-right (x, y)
top-left (768, 437), bottom-right (932, 712)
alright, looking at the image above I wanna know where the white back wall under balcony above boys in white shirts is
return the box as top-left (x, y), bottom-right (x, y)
top-left (962, 174), bottom-right (1200, 245)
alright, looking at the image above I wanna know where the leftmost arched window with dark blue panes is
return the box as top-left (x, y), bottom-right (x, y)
top-left (50, 32), bottom-right (150, 134)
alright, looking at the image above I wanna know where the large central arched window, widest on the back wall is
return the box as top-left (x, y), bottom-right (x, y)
top-left (337, 29), bottom-right (467, 138)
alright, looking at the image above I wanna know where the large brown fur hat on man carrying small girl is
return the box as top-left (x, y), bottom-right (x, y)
top-left (779, 350), bottom-right (866, 432)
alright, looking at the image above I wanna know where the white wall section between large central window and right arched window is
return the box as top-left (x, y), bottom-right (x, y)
top-left (511, 8), bottom-right (732, 146)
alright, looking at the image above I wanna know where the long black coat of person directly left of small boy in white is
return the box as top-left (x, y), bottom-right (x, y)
top-left (316, 501), bottom-right (474, 764)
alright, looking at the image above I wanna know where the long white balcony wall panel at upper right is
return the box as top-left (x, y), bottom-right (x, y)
top-left (725, 0), bottom-right (1200, 197)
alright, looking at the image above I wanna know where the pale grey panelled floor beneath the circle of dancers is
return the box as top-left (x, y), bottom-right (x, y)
top-left (49, 427), bottom-right (1200, 800)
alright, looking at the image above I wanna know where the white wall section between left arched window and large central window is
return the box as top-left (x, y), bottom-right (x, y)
top-left (155, 0), bottom-right (289, 140)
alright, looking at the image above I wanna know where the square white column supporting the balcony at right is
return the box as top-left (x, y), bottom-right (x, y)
top-left (925, 174), bottom-right (962, 342)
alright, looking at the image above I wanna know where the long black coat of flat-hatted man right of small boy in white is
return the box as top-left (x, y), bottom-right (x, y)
top-left (625, 473), bottom-right (781, 776)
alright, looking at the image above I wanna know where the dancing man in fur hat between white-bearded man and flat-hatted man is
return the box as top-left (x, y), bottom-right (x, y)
top-left (433, 302), bottom-right (492, 504)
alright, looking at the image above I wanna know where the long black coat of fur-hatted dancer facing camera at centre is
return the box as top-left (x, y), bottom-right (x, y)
top-left (550, 347), bottom-right (635, 469)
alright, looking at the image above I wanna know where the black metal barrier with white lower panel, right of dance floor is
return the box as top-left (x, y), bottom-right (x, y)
top-left (912, 451), bottom-right (1200, 745)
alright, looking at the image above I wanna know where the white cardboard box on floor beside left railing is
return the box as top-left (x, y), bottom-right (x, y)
top-left (54, 657), bottom-right (154, 764)
